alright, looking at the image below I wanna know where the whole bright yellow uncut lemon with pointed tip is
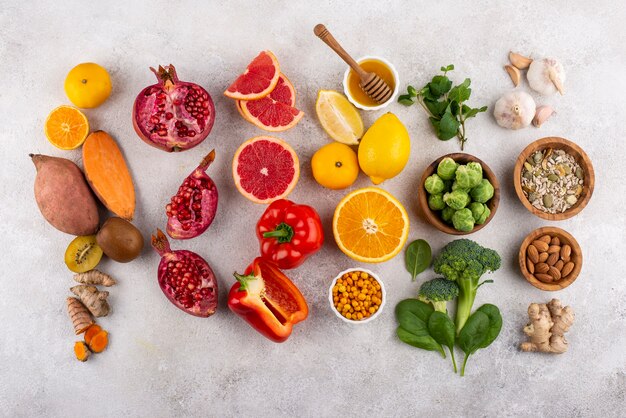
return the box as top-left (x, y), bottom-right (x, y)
top-left (359, 113), bottom-right (411, 184)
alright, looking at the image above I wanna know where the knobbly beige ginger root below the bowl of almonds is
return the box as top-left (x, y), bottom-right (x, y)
top-left (520, 299), bottom-right (574, 354)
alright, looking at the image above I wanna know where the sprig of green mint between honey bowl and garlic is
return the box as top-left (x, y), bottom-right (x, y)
top-left (398, 64), bottom-right (487, 150)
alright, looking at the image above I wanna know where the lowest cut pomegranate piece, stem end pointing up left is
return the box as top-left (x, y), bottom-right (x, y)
top-left (152, 229), bottom-right (217, 318)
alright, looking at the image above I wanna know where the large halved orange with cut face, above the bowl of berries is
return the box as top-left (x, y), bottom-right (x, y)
top-left (333, 187), bottom-right (409, 263)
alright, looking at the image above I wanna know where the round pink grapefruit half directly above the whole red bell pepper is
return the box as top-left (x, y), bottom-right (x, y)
top-left (233, 136), bottom-right (300, 203)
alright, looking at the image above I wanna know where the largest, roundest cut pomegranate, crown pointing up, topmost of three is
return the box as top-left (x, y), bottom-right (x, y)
top-left (133, 64), bottom-right (215, 152)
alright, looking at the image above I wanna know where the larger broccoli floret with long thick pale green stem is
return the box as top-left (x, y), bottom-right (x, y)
top-left (433, 239), bottom-right (501, 333)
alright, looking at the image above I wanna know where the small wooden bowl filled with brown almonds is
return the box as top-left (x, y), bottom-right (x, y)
top-left (519, 226), bottom-right (583, 292)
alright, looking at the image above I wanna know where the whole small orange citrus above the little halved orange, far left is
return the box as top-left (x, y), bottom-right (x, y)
top-left (65, 62), bottom-right (111, 109)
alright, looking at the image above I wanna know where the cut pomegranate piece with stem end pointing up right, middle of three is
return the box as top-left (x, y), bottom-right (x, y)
top-left (165, 150), bottom-right (217, 239)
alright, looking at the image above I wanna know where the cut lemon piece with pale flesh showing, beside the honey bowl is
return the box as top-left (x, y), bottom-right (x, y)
top-left (315, 90), bottom-right (364, 145)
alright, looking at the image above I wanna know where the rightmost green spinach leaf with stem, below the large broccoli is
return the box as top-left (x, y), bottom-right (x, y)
top-left (458, 304), bottom-right (502, 376)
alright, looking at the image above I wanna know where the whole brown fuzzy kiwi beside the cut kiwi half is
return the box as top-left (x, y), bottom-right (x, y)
top-left (96, 216), bottom-right (143, 263)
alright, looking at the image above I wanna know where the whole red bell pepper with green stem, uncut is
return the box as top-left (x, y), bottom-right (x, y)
top-left (257, 199), bottom-right (324, 269)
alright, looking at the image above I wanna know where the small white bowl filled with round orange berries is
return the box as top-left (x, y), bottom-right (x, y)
top-left (328, 268), bottom-right (387, 324)
